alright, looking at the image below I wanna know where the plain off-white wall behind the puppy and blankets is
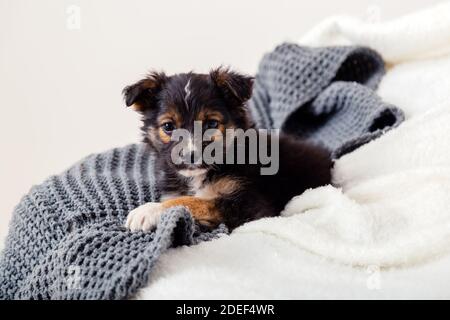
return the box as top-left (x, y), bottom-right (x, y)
top-left (0, 0), bottom-right (439, 247)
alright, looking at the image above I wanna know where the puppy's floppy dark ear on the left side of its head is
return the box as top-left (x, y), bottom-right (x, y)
top-left (122, 72), bottom-right (167, 112)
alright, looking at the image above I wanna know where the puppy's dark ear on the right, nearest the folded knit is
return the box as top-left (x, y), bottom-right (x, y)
top-left (209, 67), bottom-right (253, 105)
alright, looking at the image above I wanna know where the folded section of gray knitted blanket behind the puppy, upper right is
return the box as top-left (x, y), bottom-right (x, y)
top-left (249, 43), bottom-right (404, 158)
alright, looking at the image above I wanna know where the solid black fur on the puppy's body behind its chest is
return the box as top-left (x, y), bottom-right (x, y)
top-left (211, 135), bottom-right (332, 228)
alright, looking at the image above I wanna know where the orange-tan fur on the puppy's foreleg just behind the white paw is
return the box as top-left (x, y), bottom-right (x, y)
top-left (161, 196), bottom-right (221, 226)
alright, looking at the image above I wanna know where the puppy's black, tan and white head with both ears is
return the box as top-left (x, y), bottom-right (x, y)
top-left (123, 68), bottom-right (253, 176)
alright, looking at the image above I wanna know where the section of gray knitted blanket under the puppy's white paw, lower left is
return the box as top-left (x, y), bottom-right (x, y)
top-left (0, 144), bottom-right (227, 299)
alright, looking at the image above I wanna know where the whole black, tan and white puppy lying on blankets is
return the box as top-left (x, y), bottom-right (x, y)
top-left (123, 68), bottom-right (332, 231)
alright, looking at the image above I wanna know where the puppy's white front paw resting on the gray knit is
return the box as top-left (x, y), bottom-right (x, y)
top-left (125, 202), bottom-right (163, 231)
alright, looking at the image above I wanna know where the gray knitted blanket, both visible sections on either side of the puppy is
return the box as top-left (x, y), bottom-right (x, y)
top-left (0, 44), bottom-right (403, 299)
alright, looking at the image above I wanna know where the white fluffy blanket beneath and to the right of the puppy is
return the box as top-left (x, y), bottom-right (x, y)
top-left (140, 2), bottom-right (450, 299)
